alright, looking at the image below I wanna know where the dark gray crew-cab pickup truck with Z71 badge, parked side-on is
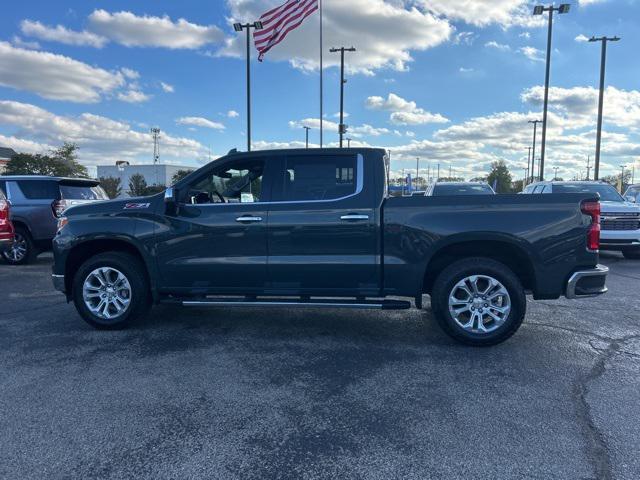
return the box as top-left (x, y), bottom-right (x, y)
top-left (53, 149), bottom-right (608, 345)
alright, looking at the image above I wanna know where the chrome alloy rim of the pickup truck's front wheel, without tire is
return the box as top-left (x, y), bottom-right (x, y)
top-left (82, 267), bottom-right (131, 320)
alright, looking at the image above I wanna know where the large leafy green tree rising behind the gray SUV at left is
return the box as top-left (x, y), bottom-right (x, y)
top-left (5, 143), bottom-right (88, 177)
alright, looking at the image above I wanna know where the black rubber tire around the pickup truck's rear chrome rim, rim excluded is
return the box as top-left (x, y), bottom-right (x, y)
top-left (431, 257), bottom-right (527, 347)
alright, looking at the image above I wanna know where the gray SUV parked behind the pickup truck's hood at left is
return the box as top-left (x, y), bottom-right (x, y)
top-left (0, 175), bottom-right (108, 265)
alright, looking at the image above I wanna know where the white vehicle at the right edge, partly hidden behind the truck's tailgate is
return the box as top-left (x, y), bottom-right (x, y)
top-left (522, 181), bottom-right (640, 260)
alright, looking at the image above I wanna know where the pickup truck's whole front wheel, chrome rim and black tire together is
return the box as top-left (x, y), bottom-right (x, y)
top-left (73, 252), bottom-right (151, 330)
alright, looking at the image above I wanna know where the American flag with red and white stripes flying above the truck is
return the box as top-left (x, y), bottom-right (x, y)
top-left (253, 0), bottom-right (318, 61)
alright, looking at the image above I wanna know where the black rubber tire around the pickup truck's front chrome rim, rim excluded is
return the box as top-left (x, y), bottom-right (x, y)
top-left (72, 252), bottom-right (151, 330)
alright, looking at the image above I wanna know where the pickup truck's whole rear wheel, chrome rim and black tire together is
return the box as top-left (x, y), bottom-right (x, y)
top-left (431, 257), bottom-right (527, 346)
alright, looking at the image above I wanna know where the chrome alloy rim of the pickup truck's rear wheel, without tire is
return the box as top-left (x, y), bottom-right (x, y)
top-left (449, 275), bottom-right (511, 334)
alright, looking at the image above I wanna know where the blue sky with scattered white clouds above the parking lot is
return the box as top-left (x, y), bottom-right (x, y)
top-left (0, 0), bottom-right (640, 179)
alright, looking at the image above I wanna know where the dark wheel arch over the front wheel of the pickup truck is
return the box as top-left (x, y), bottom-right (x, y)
top-left (64, 239), bottom-right (156, 299)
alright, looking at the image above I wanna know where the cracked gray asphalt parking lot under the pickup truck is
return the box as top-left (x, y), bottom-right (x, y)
top-left (0, 254), bottom-right (640, 479)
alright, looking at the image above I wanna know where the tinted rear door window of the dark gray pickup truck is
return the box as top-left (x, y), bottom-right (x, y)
top-left (282, 155), bottom-right (359, 201)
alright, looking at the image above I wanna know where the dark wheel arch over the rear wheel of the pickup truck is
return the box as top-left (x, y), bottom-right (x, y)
top-left (422, 239), bottom-right (536, 293)
